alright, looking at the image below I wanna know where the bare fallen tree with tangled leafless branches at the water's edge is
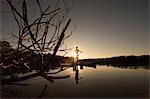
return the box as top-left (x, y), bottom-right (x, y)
top-left (1, 0), bottom-right (72, 89)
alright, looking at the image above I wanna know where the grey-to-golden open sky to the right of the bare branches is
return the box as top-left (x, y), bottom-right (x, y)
top-left (0, 0), bottom-right (150, 59)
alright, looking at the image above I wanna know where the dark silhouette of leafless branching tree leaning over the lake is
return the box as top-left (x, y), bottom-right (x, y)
top-left (1, 0), bottom-right (72, 84)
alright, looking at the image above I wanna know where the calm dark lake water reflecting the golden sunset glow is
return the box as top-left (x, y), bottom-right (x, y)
top-left (1, 65), bottom-right (150, 98)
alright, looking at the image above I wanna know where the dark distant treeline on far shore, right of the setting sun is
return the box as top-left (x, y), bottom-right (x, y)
top-left (80, 55), bottom-right (150, 66)
